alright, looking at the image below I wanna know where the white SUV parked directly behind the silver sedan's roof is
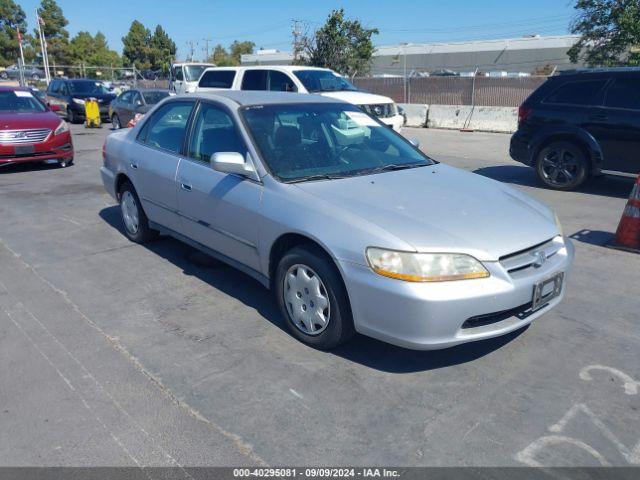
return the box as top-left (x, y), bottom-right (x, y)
top-left (195, 65), bottom-right (404, 132)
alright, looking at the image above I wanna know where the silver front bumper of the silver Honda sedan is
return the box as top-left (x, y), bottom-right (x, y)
top-left (340, 239), bottom-right (574, 350)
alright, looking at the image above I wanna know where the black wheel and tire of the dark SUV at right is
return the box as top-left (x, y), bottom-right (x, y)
top-left (536, 141), bottom-right (589, 191)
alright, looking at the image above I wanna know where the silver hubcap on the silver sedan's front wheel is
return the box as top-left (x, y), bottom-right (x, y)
top-left (283, 264), bottom-right (331, 335)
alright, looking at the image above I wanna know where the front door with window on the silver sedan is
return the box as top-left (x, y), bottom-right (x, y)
top-left (178, 103), bottom-right (262, 270)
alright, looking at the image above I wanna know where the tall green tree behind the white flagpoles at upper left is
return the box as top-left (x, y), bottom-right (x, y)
top-left (34, 0), bottom-right (70, 66)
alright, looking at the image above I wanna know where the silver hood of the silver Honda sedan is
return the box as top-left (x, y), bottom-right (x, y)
top-left (296, 164), bottom-right (559, 261)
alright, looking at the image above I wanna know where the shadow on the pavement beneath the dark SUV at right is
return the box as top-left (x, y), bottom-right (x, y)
top-left (473, 165), bottom-right (633, 198)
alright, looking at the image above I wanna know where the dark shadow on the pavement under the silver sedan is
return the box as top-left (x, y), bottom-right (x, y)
top-left (99, 205), bottom-right (527, 373)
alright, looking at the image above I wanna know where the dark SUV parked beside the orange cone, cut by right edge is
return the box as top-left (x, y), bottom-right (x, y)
top-left (509, 68), bottom-right (640, 190)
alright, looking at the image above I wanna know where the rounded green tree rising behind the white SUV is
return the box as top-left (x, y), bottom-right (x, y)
top-left (300, 8), bottom-right (378, 77)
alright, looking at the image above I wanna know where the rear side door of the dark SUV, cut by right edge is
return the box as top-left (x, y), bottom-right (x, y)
top-left (591, 76), bottom-right (640, 175)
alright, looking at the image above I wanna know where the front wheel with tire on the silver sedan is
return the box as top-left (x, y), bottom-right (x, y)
top-left (274, 246), bottom-right (355, 350)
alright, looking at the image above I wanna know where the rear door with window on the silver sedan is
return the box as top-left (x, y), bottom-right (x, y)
top-left (126, 100), bottom-right (195, 231)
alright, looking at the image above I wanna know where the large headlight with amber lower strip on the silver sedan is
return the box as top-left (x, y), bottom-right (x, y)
top-left (366, 247), bottom-right (489, 282)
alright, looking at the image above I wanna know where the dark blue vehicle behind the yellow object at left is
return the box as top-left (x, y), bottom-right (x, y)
top-left (46, 78), bottom-right (116, 123)
